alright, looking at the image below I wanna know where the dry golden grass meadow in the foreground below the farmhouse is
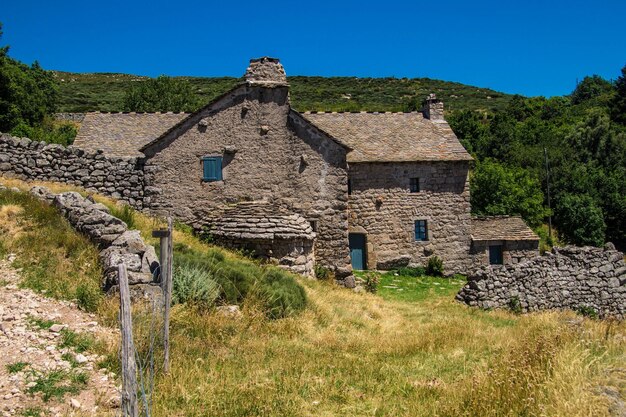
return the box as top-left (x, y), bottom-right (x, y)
top-left (1, 179), bottom-right (626, 416)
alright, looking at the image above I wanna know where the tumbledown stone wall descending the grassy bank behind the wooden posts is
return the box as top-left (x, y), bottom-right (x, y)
top-left (30, 186), bottom-right (159, 290)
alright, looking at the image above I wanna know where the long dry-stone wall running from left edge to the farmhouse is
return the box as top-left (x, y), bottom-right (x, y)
top-left (0, 134), bottom-right (144, 209)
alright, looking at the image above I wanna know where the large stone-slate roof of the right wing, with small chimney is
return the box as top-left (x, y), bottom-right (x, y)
top-left (301, 112), bottom-right (472, 163)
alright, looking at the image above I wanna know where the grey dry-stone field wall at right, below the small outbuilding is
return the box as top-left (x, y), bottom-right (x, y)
top-left (456, 244), bottom-right (626, 318)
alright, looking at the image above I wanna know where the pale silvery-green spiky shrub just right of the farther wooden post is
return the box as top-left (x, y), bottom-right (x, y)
top-left (172, 264), bottom-right (220, 307)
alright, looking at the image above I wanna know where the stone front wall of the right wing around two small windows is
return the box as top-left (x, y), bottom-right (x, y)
top-left (349, 162), bottom-right (470, 273)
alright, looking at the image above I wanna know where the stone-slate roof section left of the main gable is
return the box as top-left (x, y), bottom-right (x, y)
top-left (74, 112), bottom-right (189, 157)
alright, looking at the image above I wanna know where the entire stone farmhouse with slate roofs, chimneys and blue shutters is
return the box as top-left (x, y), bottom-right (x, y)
top-left (69, 57), bottom-right (539, 286)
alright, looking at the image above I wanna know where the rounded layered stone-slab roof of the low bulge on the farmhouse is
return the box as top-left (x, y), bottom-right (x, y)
top-left (210, 202), bottom-right (315, 240)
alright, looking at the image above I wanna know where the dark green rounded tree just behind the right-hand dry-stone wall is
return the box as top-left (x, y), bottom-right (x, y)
top-left (554, 194), bottom-right (606, 246)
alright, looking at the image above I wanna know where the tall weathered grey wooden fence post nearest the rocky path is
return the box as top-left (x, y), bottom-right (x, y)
top-left (117, 263), bottom-right (139, 417)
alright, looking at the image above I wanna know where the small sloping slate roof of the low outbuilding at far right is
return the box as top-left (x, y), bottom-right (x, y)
top-left (471, 216), bottom-right (539, 241)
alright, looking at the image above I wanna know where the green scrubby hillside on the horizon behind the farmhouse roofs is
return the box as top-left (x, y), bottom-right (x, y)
top-left (54, 71), bottom-right (512, 112)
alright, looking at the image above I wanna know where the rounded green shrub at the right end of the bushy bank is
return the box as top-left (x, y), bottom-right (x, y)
top-left (259, 268), bottom-right (307, 319)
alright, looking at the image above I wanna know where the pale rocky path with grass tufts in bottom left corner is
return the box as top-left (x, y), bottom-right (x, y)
top-left (0, 256), bottom-right (119, 417)
